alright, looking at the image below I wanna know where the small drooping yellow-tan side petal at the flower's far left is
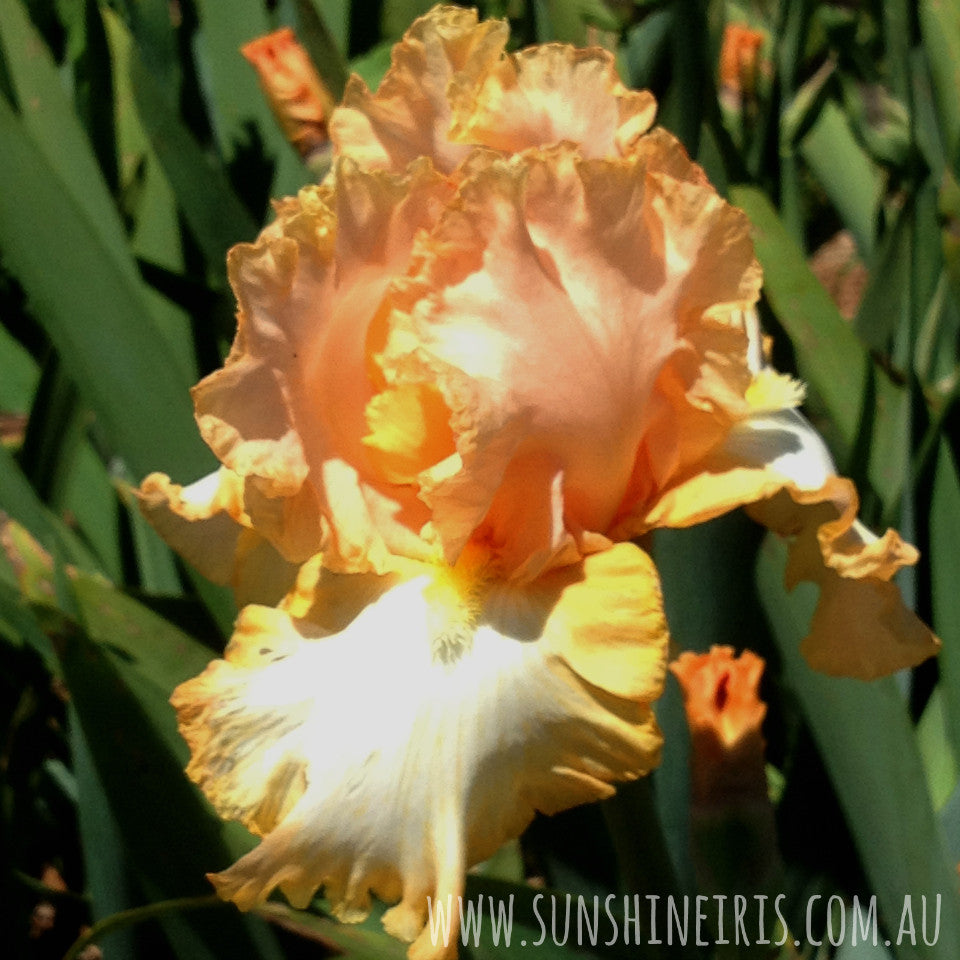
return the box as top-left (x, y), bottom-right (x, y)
top-left (137, 469), bottom-right (296, 604)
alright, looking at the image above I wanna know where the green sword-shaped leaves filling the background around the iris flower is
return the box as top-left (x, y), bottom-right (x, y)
top-left (0, 0), bottom-right (960, 960)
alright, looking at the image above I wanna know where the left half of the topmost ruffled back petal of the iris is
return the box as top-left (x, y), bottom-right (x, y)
top-left (330, 6), bottom-right (508, 173)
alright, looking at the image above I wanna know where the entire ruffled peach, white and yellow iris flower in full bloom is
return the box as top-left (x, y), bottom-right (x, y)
top-left (141, 7), bottom-right (936, 956)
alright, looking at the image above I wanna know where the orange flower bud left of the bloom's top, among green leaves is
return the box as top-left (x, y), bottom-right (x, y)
top-left (241, 27), bottom-right (335, 159)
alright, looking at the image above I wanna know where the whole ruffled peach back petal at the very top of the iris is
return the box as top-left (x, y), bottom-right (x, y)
top-left (331, 7), bottom-right (656, 173)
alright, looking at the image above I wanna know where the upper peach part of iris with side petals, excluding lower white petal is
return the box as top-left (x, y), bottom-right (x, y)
top-left (143, 7), bottom-right (935, 676)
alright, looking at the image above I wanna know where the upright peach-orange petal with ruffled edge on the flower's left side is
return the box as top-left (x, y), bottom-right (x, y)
top-left (194, 161), bottom-right (451, 569)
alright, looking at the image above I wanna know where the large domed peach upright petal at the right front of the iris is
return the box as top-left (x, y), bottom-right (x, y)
top-left (381, 146), bottom-right (759, 577)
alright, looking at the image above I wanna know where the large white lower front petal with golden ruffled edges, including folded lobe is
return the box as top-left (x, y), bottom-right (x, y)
top-left (172, 544), bottom-right (668, 958)
